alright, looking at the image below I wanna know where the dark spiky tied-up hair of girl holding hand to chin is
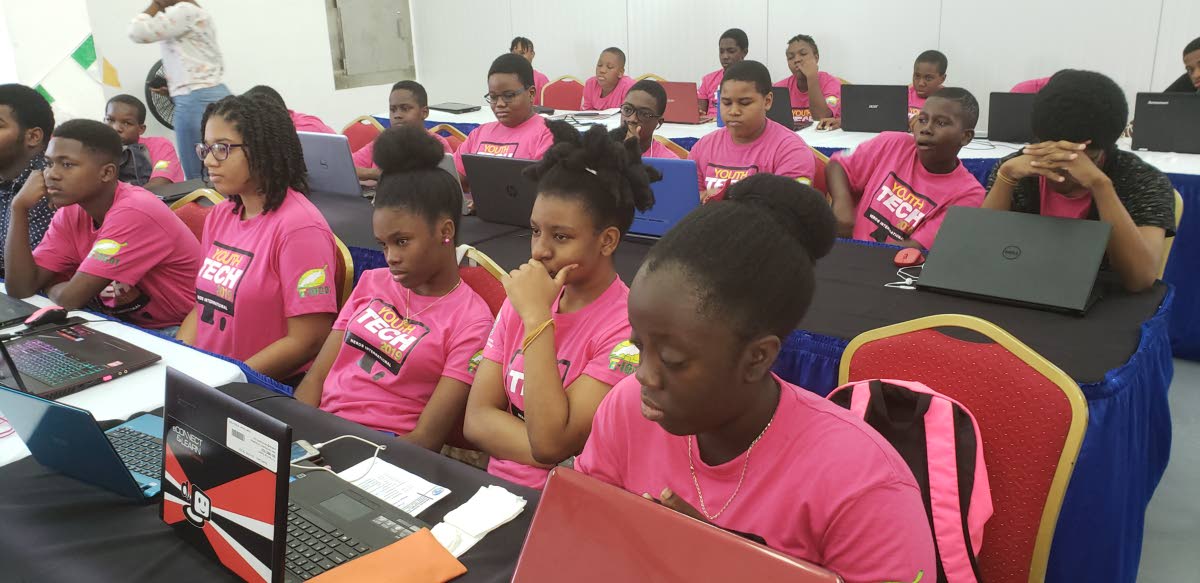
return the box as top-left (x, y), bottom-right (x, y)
top-left (524, 121), bottom-right (662, 235)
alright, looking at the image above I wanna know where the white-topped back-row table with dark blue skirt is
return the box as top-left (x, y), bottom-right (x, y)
top-left (410, 108), bottom-right (1200, 360)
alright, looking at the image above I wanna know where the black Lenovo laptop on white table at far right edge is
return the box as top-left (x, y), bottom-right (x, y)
top-left (1133, 94), bottom-right (1200, 154)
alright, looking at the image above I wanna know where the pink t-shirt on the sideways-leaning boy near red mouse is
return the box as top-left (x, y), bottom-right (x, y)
top-left (833, 132), bottom-right (988, 250)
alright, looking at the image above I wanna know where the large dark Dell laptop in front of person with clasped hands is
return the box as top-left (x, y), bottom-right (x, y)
top-left (916, 206), bottom-right (1112, 315)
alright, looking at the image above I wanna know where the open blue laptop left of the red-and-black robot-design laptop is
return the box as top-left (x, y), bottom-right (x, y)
top-left (0, 381), bottom-right (162, 500)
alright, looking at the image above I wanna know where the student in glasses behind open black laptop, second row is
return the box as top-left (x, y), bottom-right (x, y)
top-left (454, 53), bottom-right (554, 184)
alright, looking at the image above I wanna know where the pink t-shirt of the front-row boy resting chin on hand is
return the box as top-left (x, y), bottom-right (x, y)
top-left (34, 182), bottom-right (200, 329)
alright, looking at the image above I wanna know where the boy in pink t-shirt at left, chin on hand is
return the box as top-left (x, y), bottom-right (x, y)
top-left (5, 119), bottom-right (200, 329)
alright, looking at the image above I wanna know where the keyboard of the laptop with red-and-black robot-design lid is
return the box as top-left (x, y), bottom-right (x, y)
top-left (283, 503), bottom-right (391, 581)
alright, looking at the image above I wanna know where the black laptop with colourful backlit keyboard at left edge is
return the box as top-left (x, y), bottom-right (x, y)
top-left (0, 318), bottom-right (162, 398)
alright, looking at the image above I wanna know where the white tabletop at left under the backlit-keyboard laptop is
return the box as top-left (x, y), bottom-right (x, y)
top-left (0, 286), bottom-right (246, 465)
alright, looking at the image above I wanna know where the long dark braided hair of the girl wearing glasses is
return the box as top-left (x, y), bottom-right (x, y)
top-left (200, 95), bottom-right (308, 214)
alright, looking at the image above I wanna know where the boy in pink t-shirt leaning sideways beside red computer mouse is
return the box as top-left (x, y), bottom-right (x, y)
top-left (826, 88), bottom-right (986, 250)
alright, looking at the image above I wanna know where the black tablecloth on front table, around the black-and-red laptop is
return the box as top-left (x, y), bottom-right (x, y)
top-left (0, 384), bottom-right (539, 583)
